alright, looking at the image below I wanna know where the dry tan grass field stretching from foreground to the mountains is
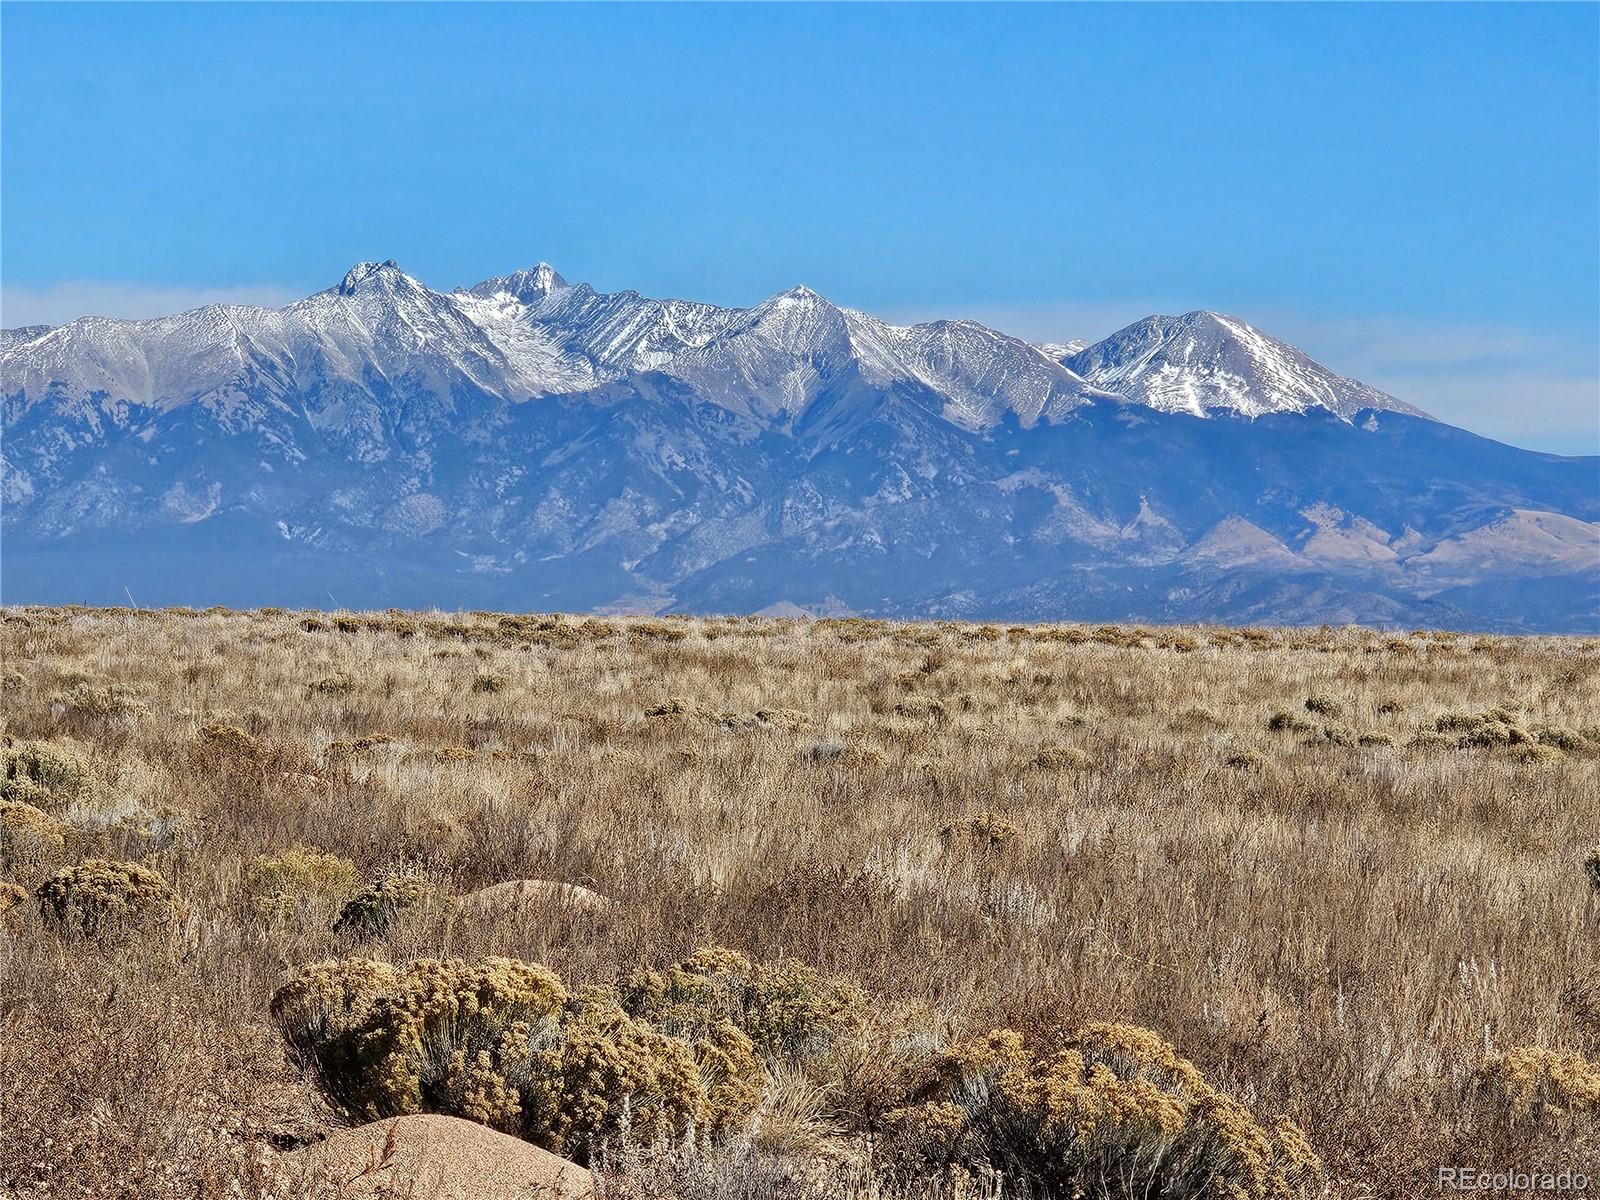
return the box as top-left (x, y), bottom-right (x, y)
top-left (0, 610), bottom-right (1600, 1200)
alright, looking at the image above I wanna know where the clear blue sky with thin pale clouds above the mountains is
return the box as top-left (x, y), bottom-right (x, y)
top-left (9, 3), bottom-right (1600, 453)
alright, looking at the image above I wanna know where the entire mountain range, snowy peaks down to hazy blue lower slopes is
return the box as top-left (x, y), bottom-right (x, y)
top-left (0, 262), bottom-right (1600, 632)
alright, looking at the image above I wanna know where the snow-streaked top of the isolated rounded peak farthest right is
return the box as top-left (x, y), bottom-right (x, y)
top-left (1066, 312), bottom-right (1426, 419)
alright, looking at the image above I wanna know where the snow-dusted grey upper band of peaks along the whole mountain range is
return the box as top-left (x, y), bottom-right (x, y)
top-left (0, 261), bottom-right (1418, 429)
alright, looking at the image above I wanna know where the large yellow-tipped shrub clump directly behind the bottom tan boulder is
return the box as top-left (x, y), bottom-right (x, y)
top-left (272, 958), bottom-right (762, 1157)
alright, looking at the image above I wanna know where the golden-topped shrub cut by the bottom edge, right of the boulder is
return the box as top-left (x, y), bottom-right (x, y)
top-left (888, 1024), bottom-right (1322, 1200)
